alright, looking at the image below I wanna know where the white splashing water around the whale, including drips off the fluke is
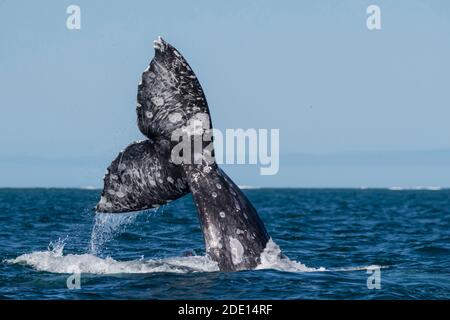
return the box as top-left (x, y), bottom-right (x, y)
top-left (5, 206), bottom-right (380, 274)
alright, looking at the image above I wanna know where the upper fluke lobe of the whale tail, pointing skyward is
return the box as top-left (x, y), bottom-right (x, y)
top-left (136, 37), bottom-right (209, 140)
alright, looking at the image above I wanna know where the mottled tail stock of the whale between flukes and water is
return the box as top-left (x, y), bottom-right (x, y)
top-left (187, 165), bottom-right (269, 271)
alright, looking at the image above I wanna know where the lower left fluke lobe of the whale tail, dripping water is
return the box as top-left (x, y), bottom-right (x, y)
top-left (95, 140), bottom-right (189, 213)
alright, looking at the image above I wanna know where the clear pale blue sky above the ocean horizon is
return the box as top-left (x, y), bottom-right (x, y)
top-left (0, 0), bottom-right (450, 187)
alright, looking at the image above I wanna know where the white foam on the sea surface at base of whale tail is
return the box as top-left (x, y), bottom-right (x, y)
top-left (5, 239), bottom-right (384, 274)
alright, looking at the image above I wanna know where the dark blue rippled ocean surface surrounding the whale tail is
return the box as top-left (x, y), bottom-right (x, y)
top-left (0, 189), bottom-right (450, 299)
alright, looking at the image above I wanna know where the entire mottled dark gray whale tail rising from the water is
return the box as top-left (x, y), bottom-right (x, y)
top-left (96, 38), bottom-right (269, 271)
